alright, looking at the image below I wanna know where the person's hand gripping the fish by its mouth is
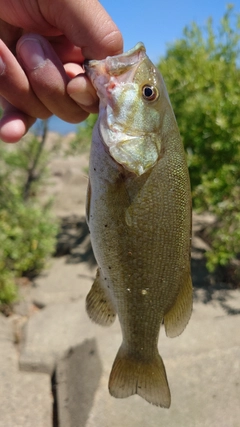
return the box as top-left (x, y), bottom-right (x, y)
top-left (0, 0), bottom-right (122, 142)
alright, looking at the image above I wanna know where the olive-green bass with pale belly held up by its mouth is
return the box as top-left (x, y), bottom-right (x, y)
top-left (85, 43), bottom-right (192, 408)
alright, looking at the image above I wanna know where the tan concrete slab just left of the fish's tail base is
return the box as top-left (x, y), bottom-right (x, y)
top-left (19, 300), bottom-right (94, 375)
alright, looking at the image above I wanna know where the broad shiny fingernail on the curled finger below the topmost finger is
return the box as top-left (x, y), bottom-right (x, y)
top-left (18, 38), bottom-right (46, 70)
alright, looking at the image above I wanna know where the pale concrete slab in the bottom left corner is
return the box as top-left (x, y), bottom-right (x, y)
top-left (0, 316), bottom-right (52, 427)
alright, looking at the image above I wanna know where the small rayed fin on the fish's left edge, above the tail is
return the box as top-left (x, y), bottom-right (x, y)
top-left (86, 269), bottom-right (116, 326)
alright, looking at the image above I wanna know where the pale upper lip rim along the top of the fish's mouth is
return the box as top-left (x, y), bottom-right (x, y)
top-left (84, 42), bottom-right (146, 78)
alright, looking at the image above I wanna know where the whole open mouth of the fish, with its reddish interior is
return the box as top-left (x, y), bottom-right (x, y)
top-left (84, 42), bottom-right (146, 89)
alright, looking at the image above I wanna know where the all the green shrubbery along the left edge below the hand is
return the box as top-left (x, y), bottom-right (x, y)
top-left (0, 122), bottom-right (58, 306)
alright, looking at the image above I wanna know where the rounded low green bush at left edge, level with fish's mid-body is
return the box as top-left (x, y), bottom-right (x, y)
top-left (0, 184), bottom-right (58, 276)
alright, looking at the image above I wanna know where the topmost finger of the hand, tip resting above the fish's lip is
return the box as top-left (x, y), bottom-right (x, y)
top-left (0, 0), bottom-right (123, 59)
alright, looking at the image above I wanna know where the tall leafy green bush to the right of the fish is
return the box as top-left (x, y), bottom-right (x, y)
top-left (159, 5), bottom-right (240, 270)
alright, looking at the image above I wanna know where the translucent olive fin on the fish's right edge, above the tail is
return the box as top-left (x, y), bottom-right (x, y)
top-left (164, 275), bottom-right (192, 338)
